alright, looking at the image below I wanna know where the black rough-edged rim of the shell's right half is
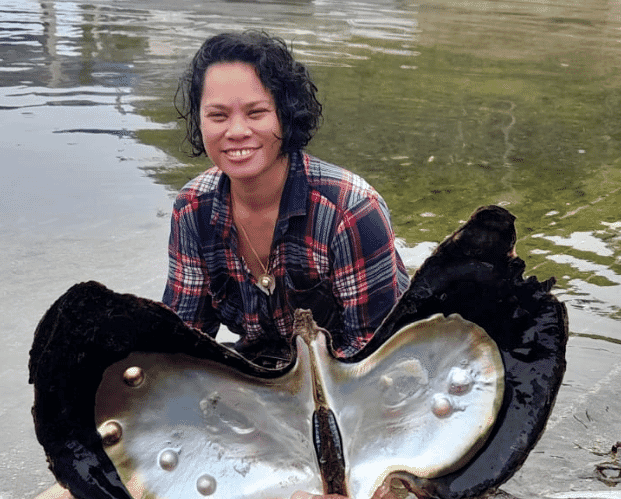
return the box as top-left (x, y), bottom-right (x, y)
top-left (360, 206), bottom-right (569, 499)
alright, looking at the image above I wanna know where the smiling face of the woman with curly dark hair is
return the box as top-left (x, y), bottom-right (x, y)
top-left (200, 62), bottom-right (287, 184)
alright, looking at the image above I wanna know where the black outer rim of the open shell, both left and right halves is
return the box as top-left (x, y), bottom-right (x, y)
top-left (29, 206), bottom-right (568, 499)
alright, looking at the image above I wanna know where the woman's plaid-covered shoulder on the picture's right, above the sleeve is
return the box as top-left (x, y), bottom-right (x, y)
top-left (304, 154), bottom-right (383, 210)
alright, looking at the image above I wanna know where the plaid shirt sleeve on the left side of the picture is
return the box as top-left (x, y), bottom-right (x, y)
top-left (162, 194), bottom-right (219, 337)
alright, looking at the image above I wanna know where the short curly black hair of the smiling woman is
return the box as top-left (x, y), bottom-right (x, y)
top-left (175, 30), bottom-right (322, 156)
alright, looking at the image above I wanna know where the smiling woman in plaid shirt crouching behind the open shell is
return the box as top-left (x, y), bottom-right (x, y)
top-left (163, 31), bottom-right (408, 367)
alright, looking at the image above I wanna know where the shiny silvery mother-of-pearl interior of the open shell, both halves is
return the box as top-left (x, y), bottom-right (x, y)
top-left (95, 315), bottom-right (504, 499)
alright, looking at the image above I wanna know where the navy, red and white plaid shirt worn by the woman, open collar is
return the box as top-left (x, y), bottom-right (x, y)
top-left (163, 153), bottom-right (409, 365)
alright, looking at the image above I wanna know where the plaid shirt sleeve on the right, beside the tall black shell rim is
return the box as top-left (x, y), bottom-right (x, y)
top-left (332, 194), bottom-right (409, 356)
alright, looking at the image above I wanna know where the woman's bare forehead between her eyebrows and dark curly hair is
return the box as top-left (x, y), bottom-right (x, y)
top-left (201, 62), bottom-right (274, 105)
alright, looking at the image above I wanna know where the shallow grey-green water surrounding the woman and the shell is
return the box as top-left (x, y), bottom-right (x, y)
top-left (0, 0), bottom-right (621, 499)
